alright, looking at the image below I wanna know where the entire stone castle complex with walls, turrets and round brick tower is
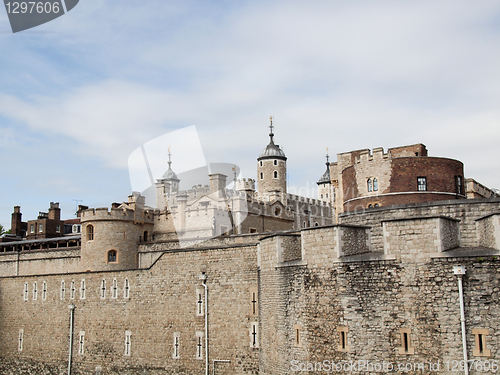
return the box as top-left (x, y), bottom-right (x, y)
top-left (0, 123), bottom-right (500, 375)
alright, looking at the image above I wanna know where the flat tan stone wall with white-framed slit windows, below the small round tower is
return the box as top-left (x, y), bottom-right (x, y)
top-left (0, 246), bottom-right (258, 375)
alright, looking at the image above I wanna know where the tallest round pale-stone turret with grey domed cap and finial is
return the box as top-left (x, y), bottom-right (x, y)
top-left (257, 117), bottom-right (286, 204)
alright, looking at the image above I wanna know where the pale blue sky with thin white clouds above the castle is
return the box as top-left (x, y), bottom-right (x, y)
top-left (0, 0), bottom-right (500, 228)
